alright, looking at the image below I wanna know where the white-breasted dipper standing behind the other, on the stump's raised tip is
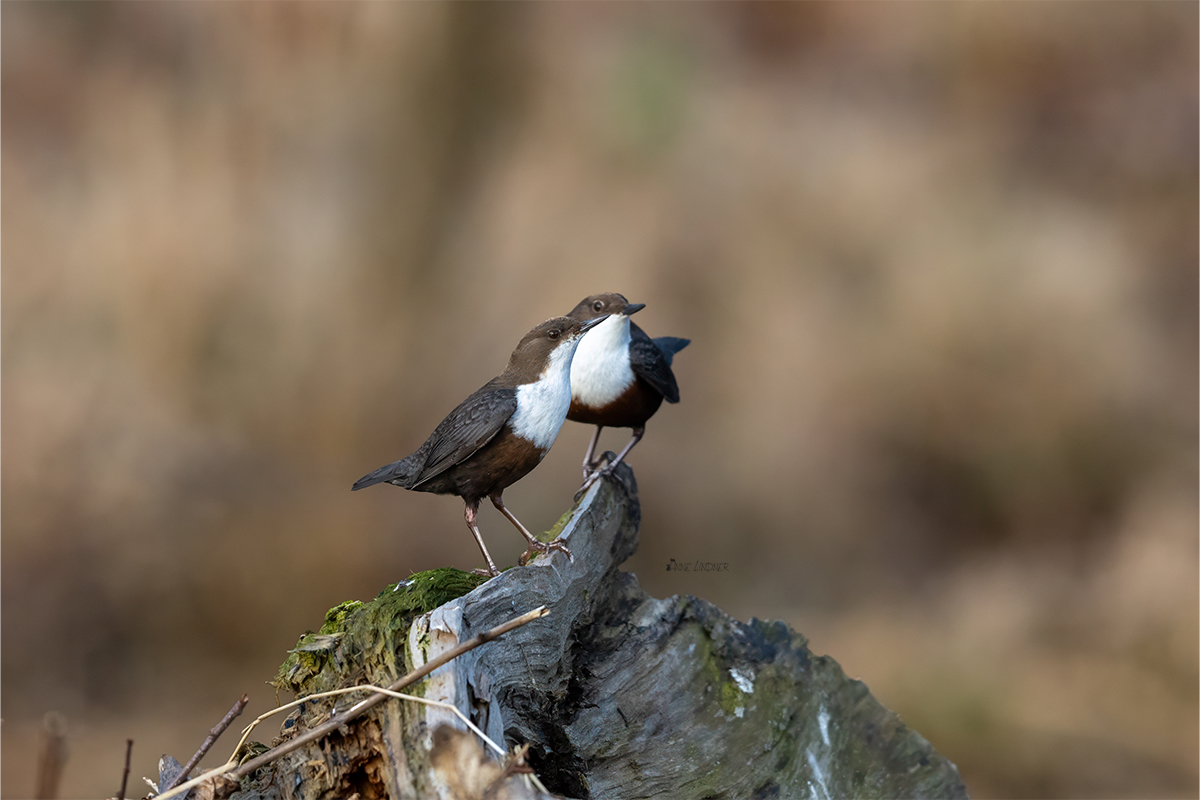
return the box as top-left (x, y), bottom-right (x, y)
top-left (566, 291), bottom-right (691, 492)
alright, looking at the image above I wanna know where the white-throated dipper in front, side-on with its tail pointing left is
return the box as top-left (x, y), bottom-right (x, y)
top-left (352, 317), bottom-right (604, 576)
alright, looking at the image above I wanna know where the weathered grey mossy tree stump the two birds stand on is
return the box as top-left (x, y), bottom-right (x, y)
top-left (169, 465), bottom-right (966, 800)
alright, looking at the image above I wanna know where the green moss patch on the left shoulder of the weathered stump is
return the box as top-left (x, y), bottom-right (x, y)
top-left (271, 567), bottom-right (486, 697)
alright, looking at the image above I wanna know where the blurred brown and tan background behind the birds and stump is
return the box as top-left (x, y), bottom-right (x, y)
top-left (0, 2), bottom-right (1200, 798)
